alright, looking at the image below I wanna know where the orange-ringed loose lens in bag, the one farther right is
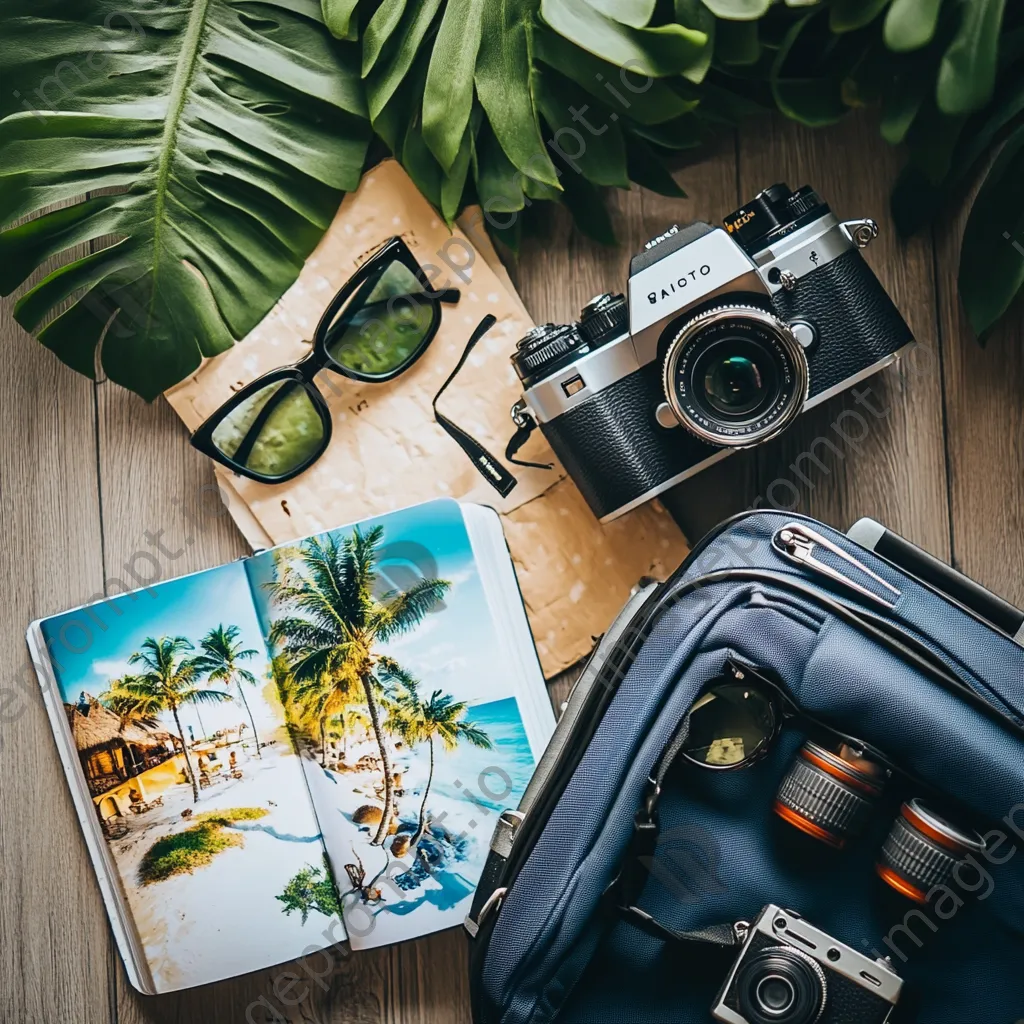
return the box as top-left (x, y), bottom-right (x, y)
top-left (876, 800), bottom-right (985, 903)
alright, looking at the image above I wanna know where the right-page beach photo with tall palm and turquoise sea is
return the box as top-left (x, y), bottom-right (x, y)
top-left (249, 501), bottom-right (535, 948)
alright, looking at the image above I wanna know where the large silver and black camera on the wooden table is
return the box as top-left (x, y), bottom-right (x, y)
top-left (512, 184), bottom-right (913, 522)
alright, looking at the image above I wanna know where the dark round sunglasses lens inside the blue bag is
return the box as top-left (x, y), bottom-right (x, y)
top-left (683, 682), bottom-right (775, 768)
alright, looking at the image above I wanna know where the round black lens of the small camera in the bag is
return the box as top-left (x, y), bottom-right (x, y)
top-left (736, 946), bottom-right (826, 1024)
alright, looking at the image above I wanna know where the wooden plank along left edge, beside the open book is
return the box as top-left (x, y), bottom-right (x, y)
top-left (0, 292), bottom-right (113, 1024)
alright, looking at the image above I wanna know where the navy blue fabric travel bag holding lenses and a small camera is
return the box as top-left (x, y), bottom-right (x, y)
top-left (467, 511), bottom-right (1024, 1024)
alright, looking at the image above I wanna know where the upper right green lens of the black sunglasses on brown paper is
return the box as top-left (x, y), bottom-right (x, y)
top-left (327, 261), bottom-right (436, 377)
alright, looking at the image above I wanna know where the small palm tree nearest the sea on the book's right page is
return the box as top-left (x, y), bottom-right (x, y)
top-left (381, 663), bottom-right (495, 850)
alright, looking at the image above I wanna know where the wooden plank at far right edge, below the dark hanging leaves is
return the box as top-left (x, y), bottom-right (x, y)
top-left (936, 198), bottom-right (1024, 608)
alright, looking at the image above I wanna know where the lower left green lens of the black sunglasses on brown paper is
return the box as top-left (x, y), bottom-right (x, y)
top-left (206, 381), bottom-right (324, 478)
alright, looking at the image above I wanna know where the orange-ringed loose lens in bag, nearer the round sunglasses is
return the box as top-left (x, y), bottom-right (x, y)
top-left (775, 740), bottom-right (888, 850)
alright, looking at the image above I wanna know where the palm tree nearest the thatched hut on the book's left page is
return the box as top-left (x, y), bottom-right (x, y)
top-left (120, 637), bottom-right (231, 803)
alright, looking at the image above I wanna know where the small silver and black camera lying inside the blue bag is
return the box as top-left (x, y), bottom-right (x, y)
top-left (712, 905), bottom-right (903, 1024)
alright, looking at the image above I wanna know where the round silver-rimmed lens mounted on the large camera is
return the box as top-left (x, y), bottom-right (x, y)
top-left (663, 306), bottom-right (809, 447)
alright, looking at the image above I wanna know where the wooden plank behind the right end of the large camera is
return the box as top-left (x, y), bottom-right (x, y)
top-left (727, 117), bottom-right (949, 557)
